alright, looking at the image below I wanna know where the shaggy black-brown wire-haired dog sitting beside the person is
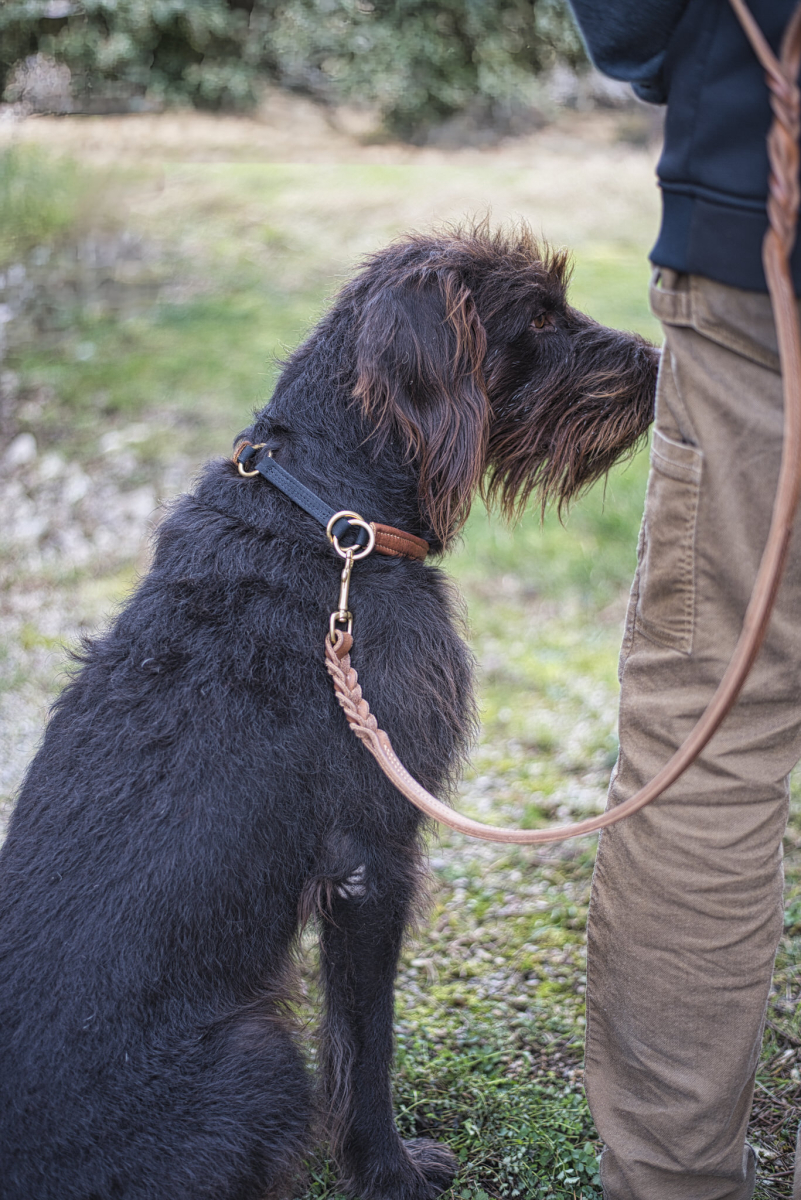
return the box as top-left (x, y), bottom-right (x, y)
top-left (0, 227), bottom-right (656, 1200)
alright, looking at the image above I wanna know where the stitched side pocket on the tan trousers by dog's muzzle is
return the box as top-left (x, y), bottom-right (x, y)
top-left (634, 430), bottom-right (703, 654)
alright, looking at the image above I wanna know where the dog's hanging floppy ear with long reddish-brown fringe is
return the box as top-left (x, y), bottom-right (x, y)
top-left (355, 270), bottom-right (489, 544)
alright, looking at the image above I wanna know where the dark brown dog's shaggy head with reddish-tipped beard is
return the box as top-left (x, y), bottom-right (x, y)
top-left (343, 224), bottom-right (658, 545)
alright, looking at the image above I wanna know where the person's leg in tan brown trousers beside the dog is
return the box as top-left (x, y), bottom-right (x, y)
top-left (586, 272), bottom-right (801, 1200)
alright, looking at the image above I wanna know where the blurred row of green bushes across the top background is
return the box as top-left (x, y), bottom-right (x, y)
top-left (0, 0), bottom-right (585, 139)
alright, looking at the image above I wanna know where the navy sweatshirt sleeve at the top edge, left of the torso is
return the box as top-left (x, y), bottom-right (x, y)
top-left (570, 0), bottom-right (687, 104)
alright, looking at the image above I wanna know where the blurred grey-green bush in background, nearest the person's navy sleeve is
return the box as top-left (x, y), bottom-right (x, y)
top-left (269, 0), bottom-right (583, 139)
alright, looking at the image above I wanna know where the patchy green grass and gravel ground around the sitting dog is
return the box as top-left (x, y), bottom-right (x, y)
top-left (0, 122), bottom-right (801, 1200)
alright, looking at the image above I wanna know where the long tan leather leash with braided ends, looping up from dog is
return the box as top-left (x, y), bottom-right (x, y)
top-left (325, 0), bottom-right (801, 845)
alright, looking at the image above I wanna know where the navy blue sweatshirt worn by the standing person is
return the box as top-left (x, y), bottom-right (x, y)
top-left (570, 0), bottom-right (801, 293)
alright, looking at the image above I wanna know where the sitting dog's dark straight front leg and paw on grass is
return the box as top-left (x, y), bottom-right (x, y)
top-left (321, 866), bottom-right (458, 1200)
